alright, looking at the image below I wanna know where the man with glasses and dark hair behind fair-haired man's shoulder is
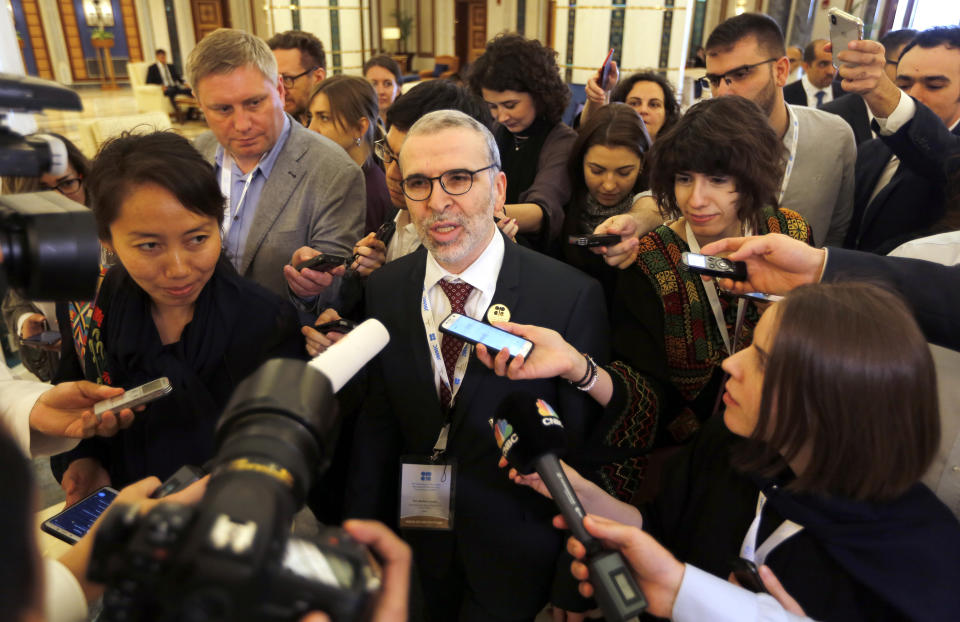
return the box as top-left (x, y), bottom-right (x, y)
top-left (267, 30), bottom-right (327, 125)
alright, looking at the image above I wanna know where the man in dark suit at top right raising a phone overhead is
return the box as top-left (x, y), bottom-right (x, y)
top-left (840, 26), bottom-right (960, 253)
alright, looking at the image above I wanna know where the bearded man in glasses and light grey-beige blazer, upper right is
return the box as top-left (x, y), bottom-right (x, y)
top-left (705, 13), bottom-right (857, 245)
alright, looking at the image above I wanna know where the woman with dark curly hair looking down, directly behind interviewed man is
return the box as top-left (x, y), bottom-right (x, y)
top-left (469, 34), bottom-right (577, 251)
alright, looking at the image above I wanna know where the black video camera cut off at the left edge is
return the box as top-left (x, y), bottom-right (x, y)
top-left (0, 74), bottom-right (100, 301)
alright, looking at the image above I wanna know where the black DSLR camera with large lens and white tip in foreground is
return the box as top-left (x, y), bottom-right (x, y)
top-left (88, 320), bottom-right (389, 622)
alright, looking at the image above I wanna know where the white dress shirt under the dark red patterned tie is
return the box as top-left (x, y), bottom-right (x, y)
top-left (423, 230), bottom-right (504, 395)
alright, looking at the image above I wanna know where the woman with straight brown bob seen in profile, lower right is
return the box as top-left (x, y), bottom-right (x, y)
top-left (492, 283), bottom-right (960, 622)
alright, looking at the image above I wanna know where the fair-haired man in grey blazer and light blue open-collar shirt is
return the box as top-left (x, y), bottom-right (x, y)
top-left (187, 28), bottom-right (366, 309)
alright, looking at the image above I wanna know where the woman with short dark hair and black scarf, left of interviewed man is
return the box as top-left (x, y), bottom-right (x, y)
top-left (51, 132), bottom-right (304, 505)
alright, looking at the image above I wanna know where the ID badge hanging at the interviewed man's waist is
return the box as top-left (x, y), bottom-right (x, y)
top-left (399, 456), bottom-right (457, 531)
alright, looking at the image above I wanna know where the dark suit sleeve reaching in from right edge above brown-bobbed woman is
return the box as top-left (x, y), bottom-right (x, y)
top-left (823, 248), bottom-right (960, 350)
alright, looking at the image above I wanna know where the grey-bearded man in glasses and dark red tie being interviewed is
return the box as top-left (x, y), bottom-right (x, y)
top-left (346, 110), bottom-right (608, 620)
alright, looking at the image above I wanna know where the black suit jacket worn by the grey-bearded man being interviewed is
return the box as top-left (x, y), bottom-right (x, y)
top-left (346, 240), bottom-right (609, 619)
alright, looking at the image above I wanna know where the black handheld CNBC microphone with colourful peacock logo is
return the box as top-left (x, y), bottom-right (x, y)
top-left (490, 392), bottom-right (647, 622)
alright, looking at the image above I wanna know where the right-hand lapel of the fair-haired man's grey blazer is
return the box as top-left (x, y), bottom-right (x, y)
top-left (240, 118), bottom-right (309, 274)
